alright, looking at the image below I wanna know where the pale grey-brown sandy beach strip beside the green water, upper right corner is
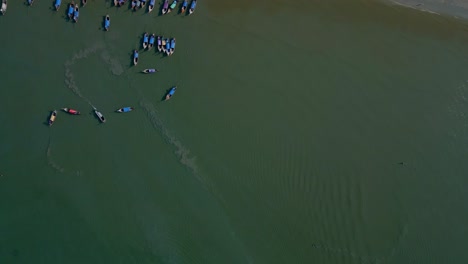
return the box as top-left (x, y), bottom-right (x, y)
top-left (388, 0), bottom-right (468, 19)
